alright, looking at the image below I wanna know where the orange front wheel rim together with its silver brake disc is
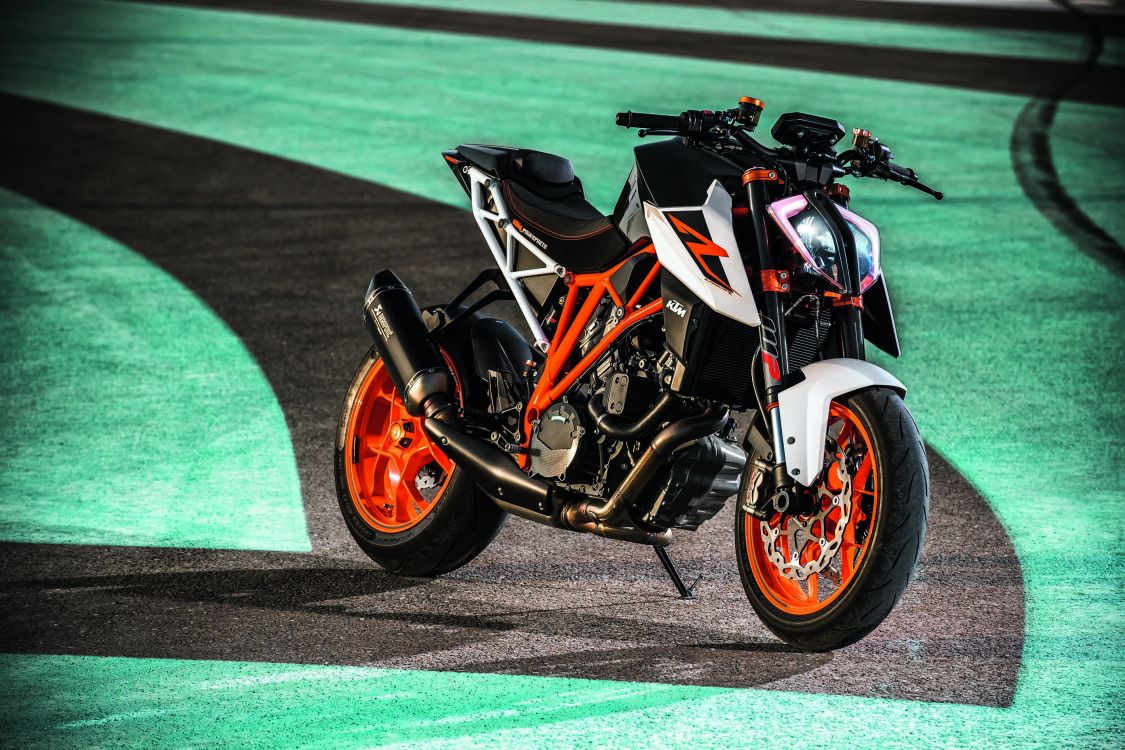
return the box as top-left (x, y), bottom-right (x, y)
top-left (744, 403), bottom-right (879, 615)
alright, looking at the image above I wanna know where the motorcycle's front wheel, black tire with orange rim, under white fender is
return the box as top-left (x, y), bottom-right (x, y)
top-left (735, 389), bottom-right (929, 651)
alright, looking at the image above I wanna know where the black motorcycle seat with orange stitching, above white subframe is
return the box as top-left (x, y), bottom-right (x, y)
top-left (457, 145), bottom-right (629, 273)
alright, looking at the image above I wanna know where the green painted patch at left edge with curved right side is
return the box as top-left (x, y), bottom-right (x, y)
top-left (0, 191), bottom-right (309, 552)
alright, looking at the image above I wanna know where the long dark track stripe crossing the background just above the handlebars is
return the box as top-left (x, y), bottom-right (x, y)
top-left (116, 0), bottom-right (1125, 106)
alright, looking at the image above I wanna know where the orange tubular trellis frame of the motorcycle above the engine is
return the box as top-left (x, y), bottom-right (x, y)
top-left (520, 244), bottom-right (664, 468)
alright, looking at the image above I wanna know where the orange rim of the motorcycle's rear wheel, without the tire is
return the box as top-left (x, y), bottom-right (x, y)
top-left (344, 360), bottom-right (453, 534)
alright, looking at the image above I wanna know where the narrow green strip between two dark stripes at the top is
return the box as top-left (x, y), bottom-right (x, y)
top-left (326, 0), bottom-right (1125, 65)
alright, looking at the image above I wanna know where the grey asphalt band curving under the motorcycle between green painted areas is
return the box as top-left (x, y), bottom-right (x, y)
top-left (0, 97), bottom-right (1024, 706)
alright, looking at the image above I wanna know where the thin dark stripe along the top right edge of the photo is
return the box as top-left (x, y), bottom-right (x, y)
top-left (585, 0), bottom-right (1125, 36)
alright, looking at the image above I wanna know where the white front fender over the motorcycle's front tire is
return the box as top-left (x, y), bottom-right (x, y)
top-left (777, 359), bottom-right (907, 486)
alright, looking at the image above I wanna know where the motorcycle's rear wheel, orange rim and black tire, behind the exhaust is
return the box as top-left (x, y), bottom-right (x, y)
top-left (335, 349), bottom-right (507, 576)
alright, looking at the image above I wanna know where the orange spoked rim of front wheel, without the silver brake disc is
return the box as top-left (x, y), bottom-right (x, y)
top-left (744, 403), bottom-right (879, 615)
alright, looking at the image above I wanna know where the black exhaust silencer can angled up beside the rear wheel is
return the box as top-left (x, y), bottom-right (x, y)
top-left (363, 270), bottom-right (453, 416)
